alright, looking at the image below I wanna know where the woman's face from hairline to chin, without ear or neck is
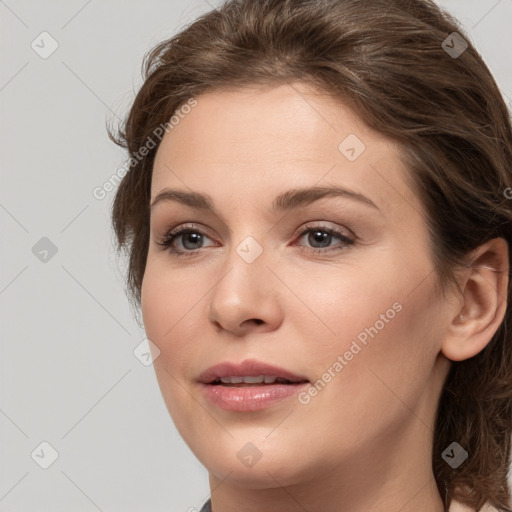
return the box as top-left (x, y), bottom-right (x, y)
top-left (142, 83), bottom-right (452, 488)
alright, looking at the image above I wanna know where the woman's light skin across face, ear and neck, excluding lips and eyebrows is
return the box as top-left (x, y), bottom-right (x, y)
top-left (142, 82), bottom-right (508, 512)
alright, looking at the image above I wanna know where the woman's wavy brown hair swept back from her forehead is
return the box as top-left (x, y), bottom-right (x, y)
top-left (110, 0), bottom-right (512, 511)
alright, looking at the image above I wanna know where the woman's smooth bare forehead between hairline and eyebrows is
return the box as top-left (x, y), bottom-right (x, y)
top-left (151, 83), bottom-right (415, 216)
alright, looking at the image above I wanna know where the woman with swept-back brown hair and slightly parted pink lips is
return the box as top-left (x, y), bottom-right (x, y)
top-left (107, 0), bottom-right (512, 512)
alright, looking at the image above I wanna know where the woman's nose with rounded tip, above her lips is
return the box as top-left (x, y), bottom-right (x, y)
top-left (208, 243), bottom-right (283, 336)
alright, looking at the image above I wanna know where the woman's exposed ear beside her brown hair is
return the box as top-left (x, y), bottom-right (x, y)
top-left (441, 238), bottom-right (509, 361)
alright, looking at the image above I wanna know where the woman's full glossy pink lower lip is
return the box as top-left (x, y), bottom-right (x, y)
top-left (201, 382), bottom-right (309, 412)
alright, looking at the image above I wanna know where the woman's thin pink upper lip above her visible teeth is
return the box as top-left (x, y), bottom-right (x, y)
top-left (197, 359), bottom-right (308, 384)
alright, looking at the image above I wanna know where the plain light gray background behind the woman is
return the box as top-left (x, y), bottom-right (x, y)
top-left (0, 0), bottom-right (512, 512)
